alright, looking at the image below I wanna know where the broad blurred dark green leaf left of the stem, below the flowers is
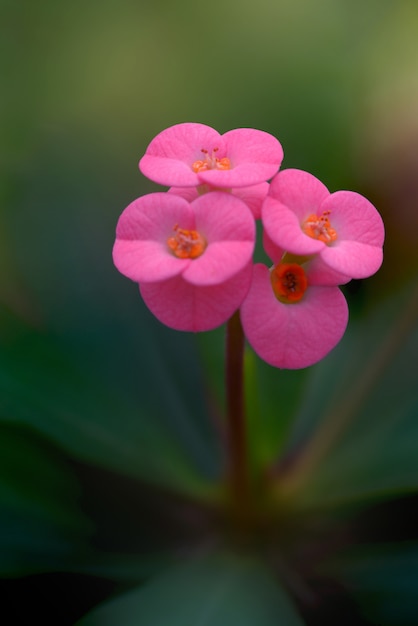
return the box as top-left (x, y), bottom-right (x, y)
top-left (0, 312), bottom-right (218, 493)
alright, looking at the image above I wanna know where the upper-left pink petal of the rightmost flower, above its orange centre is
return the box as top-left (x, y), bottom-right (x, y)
top-left (269, 169), bottom-right (330, 219)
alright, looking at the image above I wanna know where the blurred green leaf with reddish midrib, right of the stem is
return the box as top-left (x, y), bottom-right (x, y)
top-left (284, 287), bottom-right (418, 507)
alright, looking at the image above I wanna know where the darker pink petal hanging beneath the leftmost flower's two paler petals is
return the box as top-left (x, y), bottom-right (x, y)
top-left (139, 263), bottom-right (252, 332)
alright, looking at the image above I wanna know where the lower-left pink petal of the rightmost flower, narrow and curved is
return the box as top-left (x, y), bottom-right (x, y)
top-left (261, 195), bottom-right (325, 256)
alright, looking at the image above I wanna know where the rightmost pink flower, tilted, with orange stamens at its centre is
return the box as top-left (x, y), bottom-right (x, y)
top-left (262, 169), bottom-right (384, 278)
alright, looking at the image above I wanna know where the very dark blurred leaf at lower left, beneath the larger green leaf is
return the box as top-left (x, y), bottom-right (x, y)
top-left (0, 421), bottom-right (198, 584)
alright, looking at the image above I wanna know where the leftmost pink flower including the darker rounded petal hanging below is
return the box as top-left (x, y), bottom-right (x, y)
top-left (113, 191), bottom-right (255, 331)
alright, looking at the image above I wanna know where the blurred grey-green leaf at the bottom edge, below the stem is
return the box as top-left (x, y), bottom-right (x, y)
top-left (78, 554), bottom-right (303, 626)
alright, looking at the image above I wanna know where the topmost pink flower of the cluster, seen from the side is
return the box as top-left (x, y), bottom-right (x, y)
top-left (139, 123), bottom-right (283, 189)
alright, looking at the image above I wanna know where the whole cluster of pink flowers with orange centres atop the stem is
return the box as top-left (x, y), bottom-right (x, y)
top-left (113, 123), bottom-right (384, 369)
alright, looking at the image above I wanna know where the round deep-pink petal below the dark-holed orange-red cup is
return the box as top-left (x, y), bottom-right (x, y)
top-left (241, 265), bottom-right (348, 369)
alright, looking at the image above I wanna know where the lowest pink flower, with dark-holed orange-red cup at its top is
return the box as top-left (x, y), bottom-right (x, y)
top-left (241, 240), bottom-right (349, 369)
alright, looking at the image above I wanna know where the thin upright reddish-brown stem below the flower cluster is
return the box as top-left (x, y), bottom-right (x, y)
top-left (225, 311), bottom-right (249, 519)
